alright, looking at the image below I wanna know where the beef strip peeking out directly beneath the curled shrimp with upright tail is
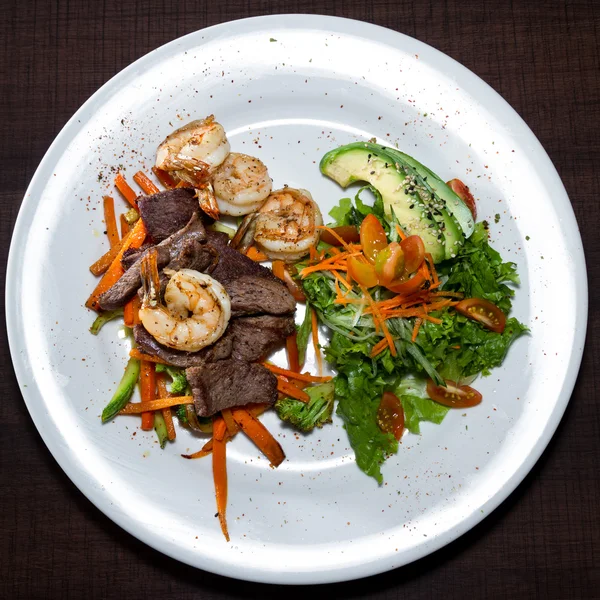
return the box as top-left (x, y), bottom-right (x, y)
top-left (133, 325), bottom-right (234, 368)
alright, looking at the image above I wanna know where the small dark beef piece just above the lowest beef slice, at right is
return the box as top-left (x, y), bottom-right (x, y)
top-left (227, 315), bottom-right (296, 362)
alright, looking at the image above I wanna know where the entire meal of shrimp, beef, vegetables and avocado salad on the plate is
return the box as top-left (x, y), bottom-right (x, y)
top-left (86, 116), bottom-right (526, 540)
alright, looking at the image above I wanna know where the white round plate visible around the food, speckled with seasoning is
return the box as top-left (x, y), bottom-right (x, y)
top-left (6, 15), bottom-right (587, 584)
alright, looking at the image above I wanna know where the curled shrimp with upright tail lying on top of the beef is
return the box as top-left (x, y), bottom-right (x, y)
top-left (139, 251), bottom-right (231, 352)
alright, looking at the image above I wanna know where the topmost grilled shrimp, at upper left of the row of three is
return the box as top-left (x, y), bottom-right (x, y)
top-left (156, 115), bottom-right (229, 186)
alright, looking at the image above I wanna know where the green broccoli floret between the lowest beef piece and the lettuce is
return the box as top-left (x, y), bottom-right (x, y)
top-left (275, 381), bottom-right (335, 431)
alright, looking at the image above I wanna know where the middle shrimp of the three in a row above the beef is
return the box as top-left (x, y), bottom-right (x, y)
top-left (212, 152), bottom-right (272, 217)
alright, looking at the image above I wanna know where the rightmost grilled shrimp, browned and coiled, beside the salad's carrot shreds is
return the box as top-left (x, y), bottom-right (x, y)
top-left (253, 188), bottom-right (323, 261)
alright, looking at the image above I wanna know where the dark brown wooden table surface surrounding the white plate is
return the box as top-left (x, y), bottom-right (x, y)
top-left (0, 0), bottom-right (600, 600)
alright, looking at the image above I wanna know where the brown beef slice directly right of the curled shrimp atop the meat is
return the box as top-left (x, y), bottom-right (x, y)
top-left (225, 275), bottom-right (296, 317)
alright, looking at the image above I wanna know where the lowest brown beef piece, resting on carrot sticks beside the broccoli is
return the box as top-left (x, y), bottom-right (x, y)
top-left (185, 359), bottom-right (277, 417)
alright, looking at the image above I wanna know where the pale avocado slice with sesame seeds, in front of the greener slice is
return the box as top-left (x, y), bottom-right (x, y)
top-left (319, 142), bottom-right (446, 263)
